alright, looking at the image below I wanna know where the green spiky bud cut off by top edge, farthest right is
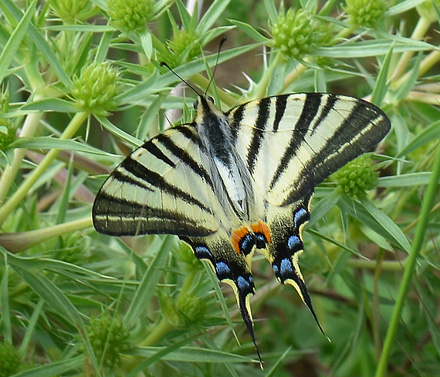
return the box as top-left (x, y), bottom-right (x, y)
top-left (344, 0), bottom-right (387, 29)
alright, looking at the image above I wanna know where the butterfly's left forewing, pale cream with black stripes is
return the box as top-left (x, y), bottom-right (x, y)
top-left (93, 125), bottom-right (222, 236)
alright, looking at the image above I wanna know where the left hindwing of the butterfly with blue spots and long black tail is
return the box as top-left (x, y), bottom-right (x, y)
top-left (181, 235), bottom-right (263, 368)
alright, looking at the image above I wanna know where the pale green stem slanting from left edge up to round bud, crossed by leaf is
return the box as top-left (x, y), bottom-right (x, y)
top-left (0, 112), bottom-right (89, 226)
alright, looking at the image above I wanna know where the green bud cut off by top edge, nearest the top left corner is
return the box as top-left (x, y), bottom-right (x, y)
top-left (49, 0), bottom-right (99, 24)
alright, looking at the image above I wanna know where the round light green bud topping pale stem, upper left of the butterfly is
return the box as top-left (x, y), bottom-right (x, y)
top-left (72, 62), bottom-right (120, 115)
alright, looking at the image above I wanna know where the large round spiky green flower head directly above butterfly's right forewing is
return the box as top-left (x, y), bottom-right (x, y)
top-left (270, 8), bottom-right (331, 60)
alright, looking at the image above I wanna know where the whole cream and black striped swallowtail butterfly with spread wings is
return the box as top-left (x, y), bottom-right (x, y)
top-left (93, 89), bottom-right (390, 365)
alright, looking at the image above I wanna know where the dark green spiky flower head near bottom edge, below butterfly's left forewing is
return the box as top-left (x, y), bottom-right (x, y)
top-left (86, 312), bottom-right (129, 370)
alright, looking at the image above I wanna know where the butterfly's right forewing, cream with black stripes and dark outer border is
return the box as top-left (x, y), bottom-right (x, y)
top-left (229, 93), bottom-right (390, 206)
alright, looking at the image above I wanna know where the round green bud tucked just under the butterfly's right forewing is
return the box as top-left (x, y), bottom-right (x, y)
top-left (334, 156), bottom-right (378, 197)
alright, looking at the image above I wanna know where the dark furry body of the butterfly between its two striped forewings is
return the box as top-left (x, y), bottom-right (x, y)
top-left (195, 96), bottom-right (255, 220)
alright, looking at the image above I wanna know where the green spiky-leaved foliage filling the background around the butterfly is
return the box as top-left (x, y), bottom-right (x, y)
top-left (0, 0), bottom-right (440, 377)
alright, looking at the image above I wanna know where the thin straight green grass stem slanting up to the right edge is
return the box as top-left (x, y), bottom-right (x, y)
top-left (376, 145), bottom-right (440, 377)
